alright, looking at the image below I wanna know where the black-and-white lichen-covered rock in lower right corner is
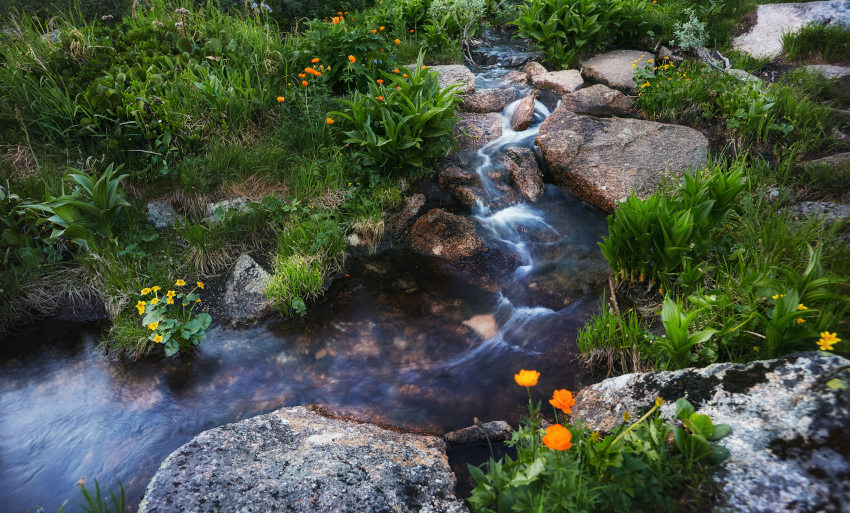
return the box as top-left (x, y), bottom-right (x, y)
top-left (572, 354), bottom-right (850, 513)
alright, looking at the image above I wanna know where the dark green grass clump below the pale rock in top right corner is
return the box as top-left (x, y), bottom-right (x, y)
top-left (782, 23), bottom-right (850, 62)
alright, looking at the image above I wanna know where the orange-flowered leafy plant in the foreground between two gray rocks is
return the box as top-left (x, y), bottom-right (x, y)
top-left (467, 371), bottom-right (730, 513)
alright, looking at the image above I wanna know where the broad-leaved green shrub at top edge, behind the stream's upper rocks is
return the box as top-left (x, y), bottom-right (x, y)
top-left (512, 0), bottom-right (648, 68)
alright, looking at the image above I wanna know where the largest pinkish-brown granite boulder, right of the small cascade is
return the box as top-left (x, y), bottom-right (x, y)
top-left (535, 106), bottom-right (708, 211)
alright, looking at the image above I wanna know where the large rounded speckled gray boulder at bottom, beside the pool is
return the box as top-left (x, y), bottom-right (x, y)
top-left (139, 406), bottom-right (467, 513)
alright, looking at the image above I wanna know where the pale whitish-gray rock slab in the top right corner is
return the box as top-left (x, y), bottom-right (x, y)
top-left (732, 0), bottom-right (850, 59)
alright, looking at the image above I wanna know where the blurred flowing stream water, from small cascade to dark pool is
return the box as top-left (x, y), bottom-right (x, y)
top-left (0, 37), bottom-right (608, 512)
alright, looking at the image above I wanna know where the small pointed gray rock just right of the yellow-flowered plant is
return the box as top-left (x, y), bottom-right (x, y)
top-left (222, 254), bottom-right (270, 325)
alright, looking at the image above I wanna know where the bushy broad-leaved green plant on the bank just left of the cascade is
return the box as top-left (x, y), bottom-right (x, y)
top-left (329, 53), bottom-right (459, 178)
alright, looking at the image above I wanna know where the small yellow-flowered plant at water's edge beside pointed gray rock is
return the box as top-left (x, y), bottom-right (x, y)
top-left (135, 279), bottom-right (212, 356)
